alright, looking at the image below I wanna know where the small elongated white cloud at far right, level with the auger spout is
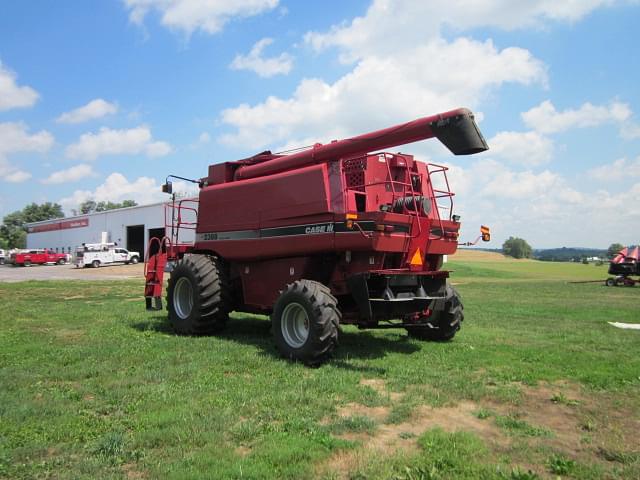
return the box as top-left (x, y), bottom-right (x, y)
top-left (521, 100), bottom-right (632, 134)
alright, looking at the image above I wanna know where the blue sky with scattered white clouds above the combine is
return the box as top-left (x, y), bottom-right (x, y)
top-left (0, 0), bottom-right (640, 248)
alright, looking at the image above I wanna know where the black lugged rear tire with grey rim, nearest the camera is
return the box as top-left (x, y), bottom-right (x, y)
top-left (271, 280), bottom-right (342, 366)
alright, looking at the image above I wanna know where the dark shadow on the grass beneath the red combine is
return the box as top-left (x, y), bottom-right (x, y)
top-left (131, 314), bottom-right (420, 373)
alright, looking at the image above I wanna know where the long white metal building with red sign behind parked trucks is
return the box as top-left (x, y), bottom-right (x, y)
top-left (27, 200), bottom-right (197, 255)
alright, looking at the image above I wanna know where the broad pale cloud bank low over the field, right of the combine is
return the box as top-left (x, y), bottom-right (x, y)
top-left (440, 157), bottom-right (640, 248)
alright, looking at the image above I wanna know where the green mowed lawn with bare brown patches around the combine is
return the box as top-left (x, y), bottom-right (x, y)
top-left (0, 251), bottom-right (640, 479)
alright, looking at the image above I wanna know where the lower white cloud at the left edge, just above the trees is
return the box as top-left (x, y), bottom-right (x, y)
top-left (0, 122), bottom-right (54, 183)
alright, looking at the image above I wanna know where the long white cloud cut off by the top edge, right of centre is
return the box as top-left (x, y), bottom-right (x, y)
top-left (305, 0), bottom-right (615, 62)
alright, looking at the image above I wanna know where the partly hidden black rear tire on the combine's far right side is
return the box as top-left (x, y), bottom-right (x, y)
top-left (407, 285), bottom-right (464, 342)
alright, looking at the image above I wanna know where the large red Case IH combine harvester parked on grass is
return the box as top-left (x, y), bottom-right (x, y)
top-left (145, 108), bottom-right (490, 365)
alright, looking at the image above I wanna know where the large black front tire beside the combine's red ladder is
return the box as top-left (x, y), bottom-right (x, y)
top-left (167, 255), bottom-right (230, 335)
